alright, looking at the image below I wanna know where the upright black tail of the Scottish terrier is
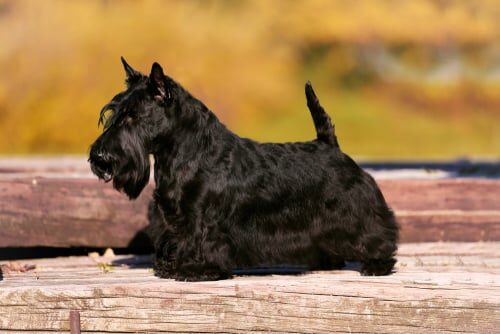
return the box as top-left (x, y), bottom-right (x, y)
top-left (306, 81), bottom-right (339, 147)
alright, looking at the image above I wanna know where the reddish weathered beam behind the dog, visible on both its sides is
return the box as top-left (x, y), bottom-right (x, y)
top-left (0, 159), bottom-right (500, 247)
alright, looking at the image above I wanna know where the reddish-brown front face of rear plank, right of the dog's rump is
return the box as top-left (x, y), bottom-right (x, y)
top-left (377, 179), bottom-right (500, 242)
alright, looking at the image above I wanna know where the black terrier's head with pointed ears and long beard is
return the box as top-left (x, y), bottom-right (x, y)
top-left (89, 58), bottom-right (184, 199)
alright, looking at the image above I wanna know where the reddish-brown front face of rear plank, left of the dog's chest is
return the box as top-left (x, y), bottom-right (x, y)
top-left (0, 178), bottom-right (151, 247)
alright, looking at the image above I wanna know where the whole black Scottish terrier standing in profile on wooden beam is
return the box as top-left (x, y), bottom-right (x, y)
top-left (89, 58), bottom-right (398, 281)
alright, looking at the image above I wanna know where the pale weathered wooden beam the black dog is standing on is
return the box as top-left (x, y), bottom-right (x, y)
top-left (0, 242), bottom-right (500, 333)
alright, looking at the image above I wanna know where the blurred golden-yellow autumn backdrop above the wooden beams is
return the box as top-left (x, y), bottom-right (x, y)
top-left (0, 0), bottom-right (500, 160)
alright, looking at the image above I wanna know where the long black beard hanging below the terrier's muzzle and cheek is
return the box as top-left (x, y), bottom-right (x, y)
top-left (113, 134), bottom-right (151, 199)
